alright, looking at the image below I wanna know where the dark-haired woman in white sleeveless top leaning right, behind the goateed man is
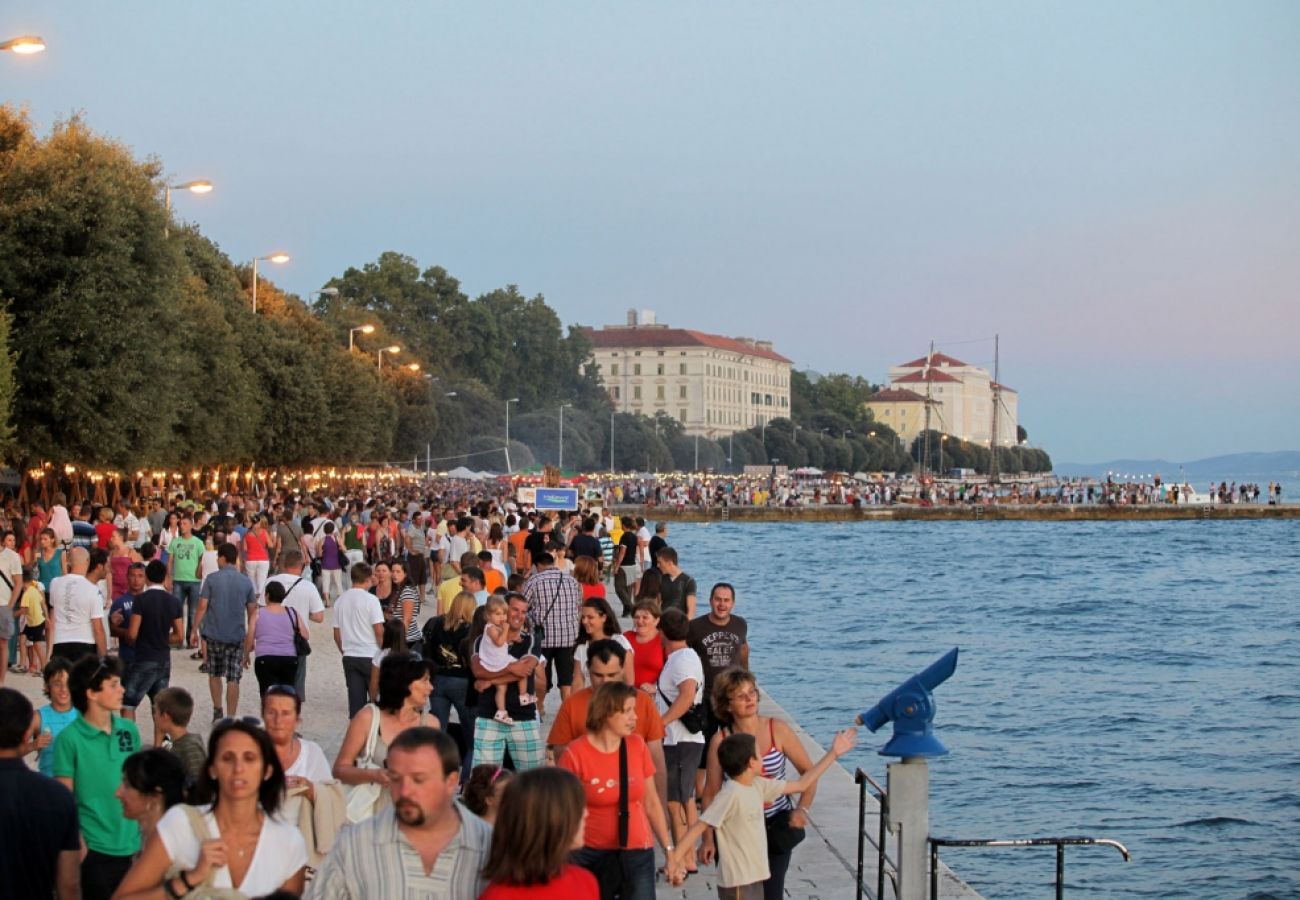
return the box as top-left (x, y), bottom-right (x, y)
top-left (334, 653), bottom-right (442, 822)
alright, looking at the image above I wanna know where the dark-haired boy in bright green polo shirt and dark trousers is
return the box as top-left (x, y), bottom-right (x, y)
top-left (55, 657), bottom-right (140, 900)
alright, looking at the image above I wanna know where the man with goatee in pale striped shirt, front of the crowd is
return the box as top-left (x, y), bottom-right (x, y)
top-left (307, 726), bottom-right (491, 900)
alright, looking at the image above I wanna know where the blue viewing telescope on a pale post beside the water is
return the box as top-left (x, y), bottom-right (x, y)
top-left (858, 646), bottom-right (957, 900)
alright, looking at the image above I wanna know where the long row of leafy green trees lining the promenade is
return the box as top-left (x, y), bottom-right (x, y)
top-left (0, 107), bottom-right (1050, 472)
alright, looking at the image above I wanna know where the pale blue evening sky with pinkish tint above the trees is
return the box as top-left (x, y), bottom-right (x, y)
top-left (0, 0), bottom-right (1300, 462)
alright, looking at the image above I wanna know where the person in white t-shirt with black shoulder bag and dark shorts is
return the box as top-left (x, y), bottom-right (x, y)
top-left (655, 609), bottom-right (705, 874)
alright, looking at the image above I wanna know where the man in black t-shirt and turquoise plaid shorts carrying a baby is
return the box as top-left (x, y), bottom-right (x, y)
top-left (469, 593), bottom-right (546, 771)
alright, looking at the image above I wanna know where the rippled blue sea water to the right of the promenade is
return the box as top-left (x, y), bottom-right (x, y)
top-left (670, 520), bottom-right (1300, 900)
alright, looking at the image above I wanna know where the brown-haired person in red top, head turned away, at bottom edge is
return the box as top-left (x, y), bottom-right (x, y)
top-left (478, 769), bottom-right (601, 900)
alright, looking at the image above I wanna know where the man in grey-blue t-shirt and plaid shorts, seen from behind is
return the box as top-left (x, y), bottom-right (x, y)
top-left (194, 544), bottom-right (257, 722)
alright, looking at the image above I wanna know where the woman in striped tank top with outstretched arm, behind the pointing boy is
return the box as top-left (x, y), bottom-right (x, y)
top-left (702, 668), bottom-right (816, 900)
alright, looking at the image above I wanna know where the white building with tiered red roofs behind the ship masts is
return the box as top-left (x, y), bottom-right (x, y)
top-left (867, 352), bottom-right (1019, 447)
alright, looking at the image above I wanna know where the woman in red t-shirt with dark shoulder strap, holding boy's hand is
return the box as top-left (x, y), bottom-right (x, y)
top-left (559, 682), bottom-right (685, 900)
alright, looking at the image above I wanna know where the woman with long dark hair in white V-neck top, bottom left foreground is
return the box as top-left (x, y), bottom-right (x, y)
top-left (113, 719), bottom-right (307, 900)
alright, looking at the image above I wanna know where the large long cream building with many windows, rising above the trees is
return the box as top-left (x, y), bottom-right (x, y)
top-left (586, 310), bottom-right (790, 438)
